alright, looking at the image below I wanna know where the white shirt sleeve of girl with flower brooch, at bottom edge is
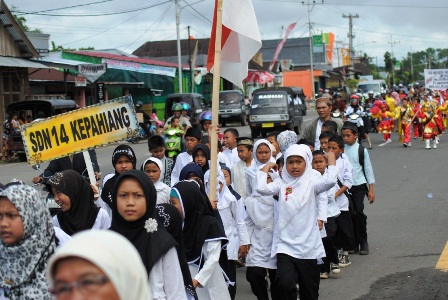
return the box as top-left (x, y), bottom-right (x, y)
top-left (149, 247), bottom-right (187, 300)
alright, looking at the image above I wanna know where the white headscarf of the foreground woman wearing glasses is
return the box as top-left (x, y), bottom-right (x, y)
top-left (48, 230), bottom-right (152, 300)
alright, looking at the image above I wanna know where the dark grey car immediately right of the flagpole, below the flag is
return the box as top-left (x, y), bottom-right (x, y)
top-left (219, 90), bottom-right (246, 126)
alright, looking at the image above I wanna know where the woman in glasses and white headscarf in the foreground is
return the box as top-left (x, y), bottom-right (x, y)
top-left (48, 230), bottom-right (152, 300)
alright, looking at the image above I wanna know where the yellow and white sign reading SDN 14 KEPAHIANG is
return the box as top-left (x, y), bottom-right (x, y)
top-left (22, 97), bottom-right (139, 164)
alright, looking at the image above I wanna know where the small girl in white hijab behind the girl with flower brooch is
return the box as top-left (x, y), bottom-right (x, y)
top-left (140, 157), bottom-right (171, 204)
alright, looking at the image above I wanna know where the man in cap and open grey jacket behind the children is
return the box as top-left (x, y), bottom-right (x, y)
top-left (302, 94), bottom-right (342, 149)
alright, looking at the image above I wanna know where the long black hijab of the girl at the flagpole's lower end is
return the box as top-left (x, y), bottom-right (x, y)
top-left (173, 180), bottom-right (227, 264)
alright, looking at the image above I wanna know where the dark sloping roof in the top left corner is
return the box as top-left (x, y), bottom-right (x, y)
top-left (0, 0), bottom-right (39, 57)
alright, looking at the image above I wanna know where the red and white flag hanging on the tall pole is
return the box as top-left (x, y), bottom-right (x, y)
top-left (207, 0), bottom-right (261, 89)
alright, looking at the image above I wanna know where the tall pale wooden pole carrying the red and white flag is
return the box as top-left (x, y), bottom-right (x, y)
top-left (210, 0), bottom-right (223, 209)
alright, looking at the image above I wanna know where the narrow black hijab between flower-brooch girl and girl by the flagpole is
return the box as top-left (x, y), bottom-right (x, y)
top-left (156, 203), bottom-right (198, 300)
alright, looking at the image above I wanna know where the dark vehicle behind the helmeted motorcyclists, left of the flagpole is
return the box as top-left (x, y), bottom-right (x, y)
top-left (165, 93), bottom-right (208, 126)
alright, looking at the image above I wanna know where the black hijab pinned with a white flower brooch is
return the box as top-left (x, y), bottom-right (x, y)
top-left (110, 170), bottom-right (176, 276)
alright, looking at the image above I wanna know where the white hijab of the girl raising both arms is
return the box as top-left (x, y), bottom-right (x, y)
top-left (278, 145), bottom-right (322, 230)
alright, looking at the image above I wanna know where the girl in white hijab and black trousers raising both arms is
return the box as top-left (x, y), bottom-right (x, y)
top-left (257, 145), bottom-right (337, 299)
